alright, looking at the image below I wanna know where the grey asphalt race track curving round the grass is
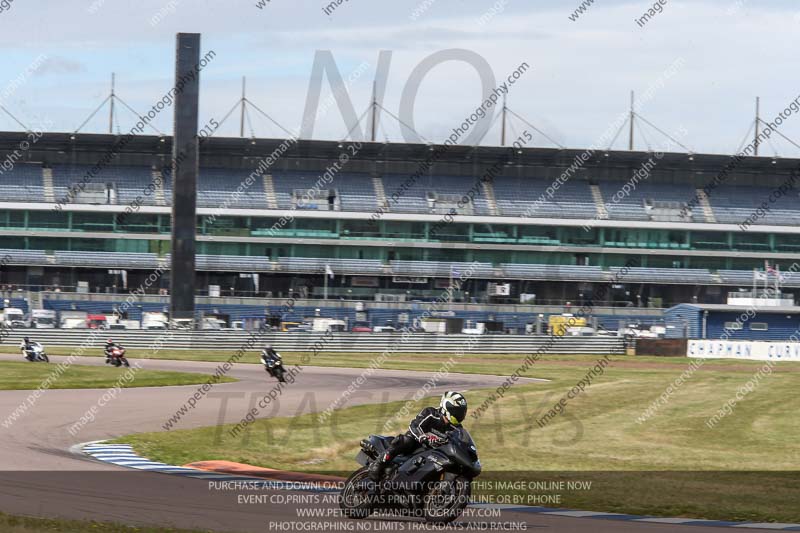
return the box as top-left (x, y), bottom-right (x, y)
top-left (0, 356), bottom-right (768, 533)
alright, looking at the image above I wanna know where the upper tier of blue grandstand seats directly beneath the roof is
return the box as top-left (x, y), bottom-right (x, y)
top-left (0, 163), bottom-right (800, 226)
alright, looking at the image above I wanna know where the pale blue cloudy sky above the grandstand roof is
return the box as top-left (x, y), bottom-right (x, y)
top-left (0, 0), bottom-right (800, 157)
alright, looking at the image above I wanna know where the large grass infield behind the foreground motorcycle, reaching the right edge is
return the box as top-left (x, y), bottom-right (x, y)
top-left (118, 354), bottom-right (800, 522)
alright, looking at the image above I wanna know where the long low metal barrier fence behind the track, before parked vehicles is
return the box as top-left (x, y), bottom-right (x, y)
top-left (3, 329), bottom-right (625, 357)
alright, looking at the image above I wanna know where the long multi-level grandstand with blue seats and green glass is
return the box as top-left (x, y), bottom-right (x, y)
top-left (0, 133), bottom-right (800, 328)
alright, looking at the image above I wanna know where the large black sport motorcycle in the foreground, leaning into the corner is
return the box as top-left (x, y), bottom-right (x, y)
top-left (339, 428), bottom-right (481, 524)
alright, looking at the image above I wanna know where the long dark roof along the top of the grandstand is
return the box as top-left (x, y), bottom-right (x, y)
top-left (0, 131), bottom-right (800, 175)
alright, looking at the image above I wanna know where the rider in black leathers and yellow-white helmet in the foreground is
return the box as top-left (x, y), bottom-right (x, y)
top-left (369, 391), bottom-right (467, 482)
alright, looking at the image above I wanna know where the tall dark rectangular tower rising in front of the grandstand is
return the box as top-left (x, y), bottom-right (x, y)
top-left (170, 33), bottom-right (200, 319)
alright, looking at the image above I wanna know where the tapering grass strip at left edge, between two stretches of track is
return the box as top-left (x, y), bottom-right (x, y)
top-left (0, 361), bottom-right (236, 390)
